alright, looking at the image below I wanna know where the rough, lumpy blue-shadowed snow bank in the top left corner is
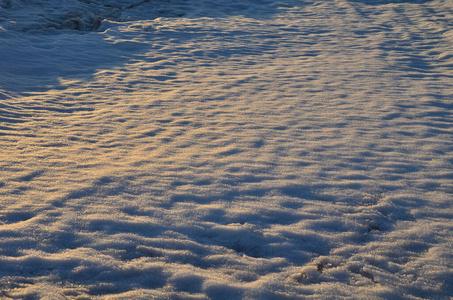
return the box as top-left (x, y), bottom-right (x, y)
top-left (0, 0), bottom-right (183, 32)
